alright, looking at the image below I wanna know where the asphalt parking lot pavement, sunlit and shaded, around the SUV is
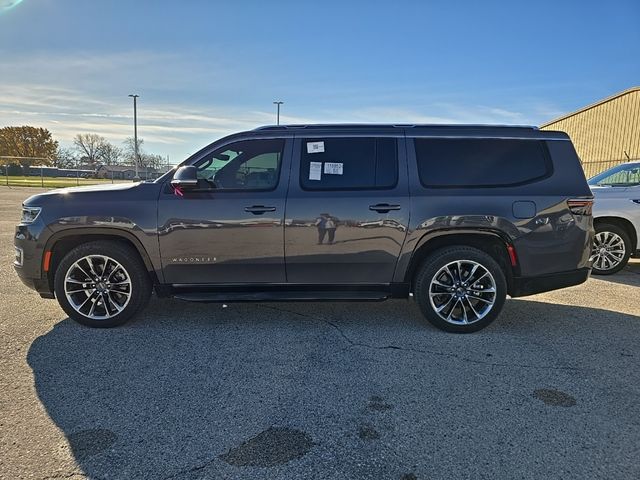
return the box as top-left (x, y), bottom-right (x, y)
top-left (0, 187), bottom-right (640, 480)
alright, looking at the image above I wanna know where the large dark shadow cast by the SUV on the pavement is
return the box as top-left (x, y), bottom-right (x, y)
top-left (28, 299), bottom-right (640, 479)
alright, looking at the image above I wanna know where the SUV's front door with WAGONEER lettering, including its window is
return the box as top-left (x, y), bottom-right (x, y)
top-left (158, 139), bottom-right (291, 284)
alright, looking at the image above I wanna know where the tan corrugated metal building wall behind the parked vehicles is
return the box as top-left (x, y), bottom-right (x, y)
top-left (540, 87), bottom-right (640, 177)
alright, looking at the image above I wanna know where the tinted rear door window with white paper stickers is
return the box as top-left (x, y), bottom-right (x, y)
top-left (300, 137), bottom-right (398, 190)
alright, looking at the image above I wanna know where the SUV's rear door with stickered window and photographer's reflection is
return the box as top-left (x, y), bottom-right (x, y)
top-left (284, 129), bottom-right (409, 285)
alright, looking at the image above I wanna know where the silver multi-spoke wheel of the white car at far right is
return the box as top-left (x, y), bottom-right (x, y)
top-left (590, 223), bottom-right (632, 275)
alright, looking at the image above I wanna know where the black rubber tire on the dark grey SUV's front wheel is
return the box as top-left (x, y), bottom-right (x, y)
top-left (54, 240), bottom-right (153, 328)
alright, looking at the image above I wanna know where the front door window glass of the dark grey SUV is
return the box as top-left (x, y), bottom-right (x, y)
top-left (196, 139), bottom-right (284, 190)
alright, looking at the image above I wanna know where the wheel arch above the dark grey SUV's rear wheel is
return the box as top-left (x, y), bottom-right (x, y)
top-left (405, 229), bottom-right (519, 293)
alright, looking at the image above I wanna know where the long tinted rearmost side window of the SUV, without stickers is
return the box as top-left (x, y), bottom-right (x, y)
top-left (414, 138), bottom-right (551, 188)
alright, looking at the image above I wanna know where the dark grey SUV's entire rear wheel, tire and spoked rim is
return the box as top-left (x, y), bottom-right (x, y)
top-left (414, 246), bottom-right (507, 333)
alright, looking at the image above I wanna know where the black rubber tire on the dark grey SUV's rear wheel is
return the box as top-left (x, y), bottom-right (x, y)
top-left (414, 246), bottom-right (507, 333)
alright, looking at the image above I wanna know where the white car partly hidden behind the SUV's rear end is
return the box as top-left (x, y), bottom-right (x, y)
top-left (589, 161), bottom-right (640, 275)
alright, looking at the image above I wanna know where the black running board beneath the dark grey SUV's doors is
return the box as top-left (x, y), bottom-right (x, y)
top-left (172, 290), bottom-right (391, 303)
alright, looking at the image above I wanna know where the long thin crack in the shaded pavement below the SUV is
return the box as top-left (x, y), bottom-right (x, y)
top-left (259, 305), bottom-right (586, 372)
